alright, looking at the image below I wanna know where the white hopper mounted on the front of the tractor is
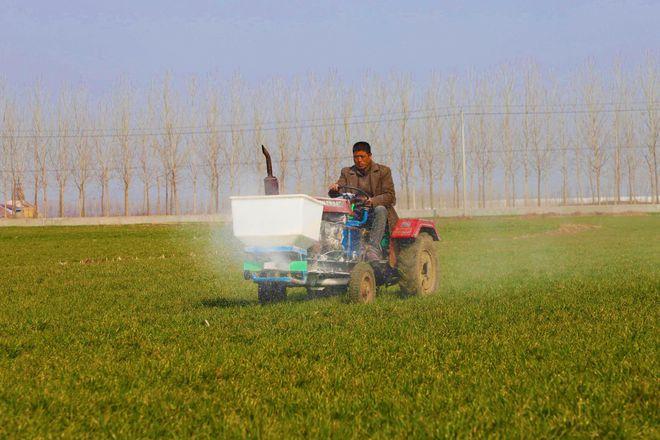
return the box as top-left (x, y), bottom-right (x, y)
top-left (231, 194), bottom-right (323, 249)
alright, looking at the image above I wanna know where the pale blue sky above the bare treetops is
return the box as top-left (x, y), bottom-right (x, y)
top-left (0, 0), bottom-right (660, 90)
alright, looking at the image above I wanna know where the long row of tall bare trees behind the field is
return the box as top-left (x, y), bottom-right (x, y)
top-left (0, 56), bottom-right (660, 216)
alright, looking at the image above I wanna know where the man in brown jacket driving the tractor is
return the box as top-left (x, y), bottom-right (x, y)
top-left (329, 141), bottom-right (398, 261)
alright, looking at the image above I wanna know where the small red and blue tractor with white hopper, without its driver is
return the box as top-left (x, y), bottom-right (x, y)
top-left (231, 147), bottom-right (439, 303)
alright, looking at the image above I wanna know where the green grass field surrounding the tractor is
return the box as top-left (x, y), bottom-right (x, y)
top-left (0, 215), bottom-right (660, 438)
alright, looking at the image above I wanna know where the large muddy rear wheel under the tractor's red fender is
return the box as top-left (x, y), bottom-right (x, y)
top-left (397, 232), bottom-right (440, 296)
